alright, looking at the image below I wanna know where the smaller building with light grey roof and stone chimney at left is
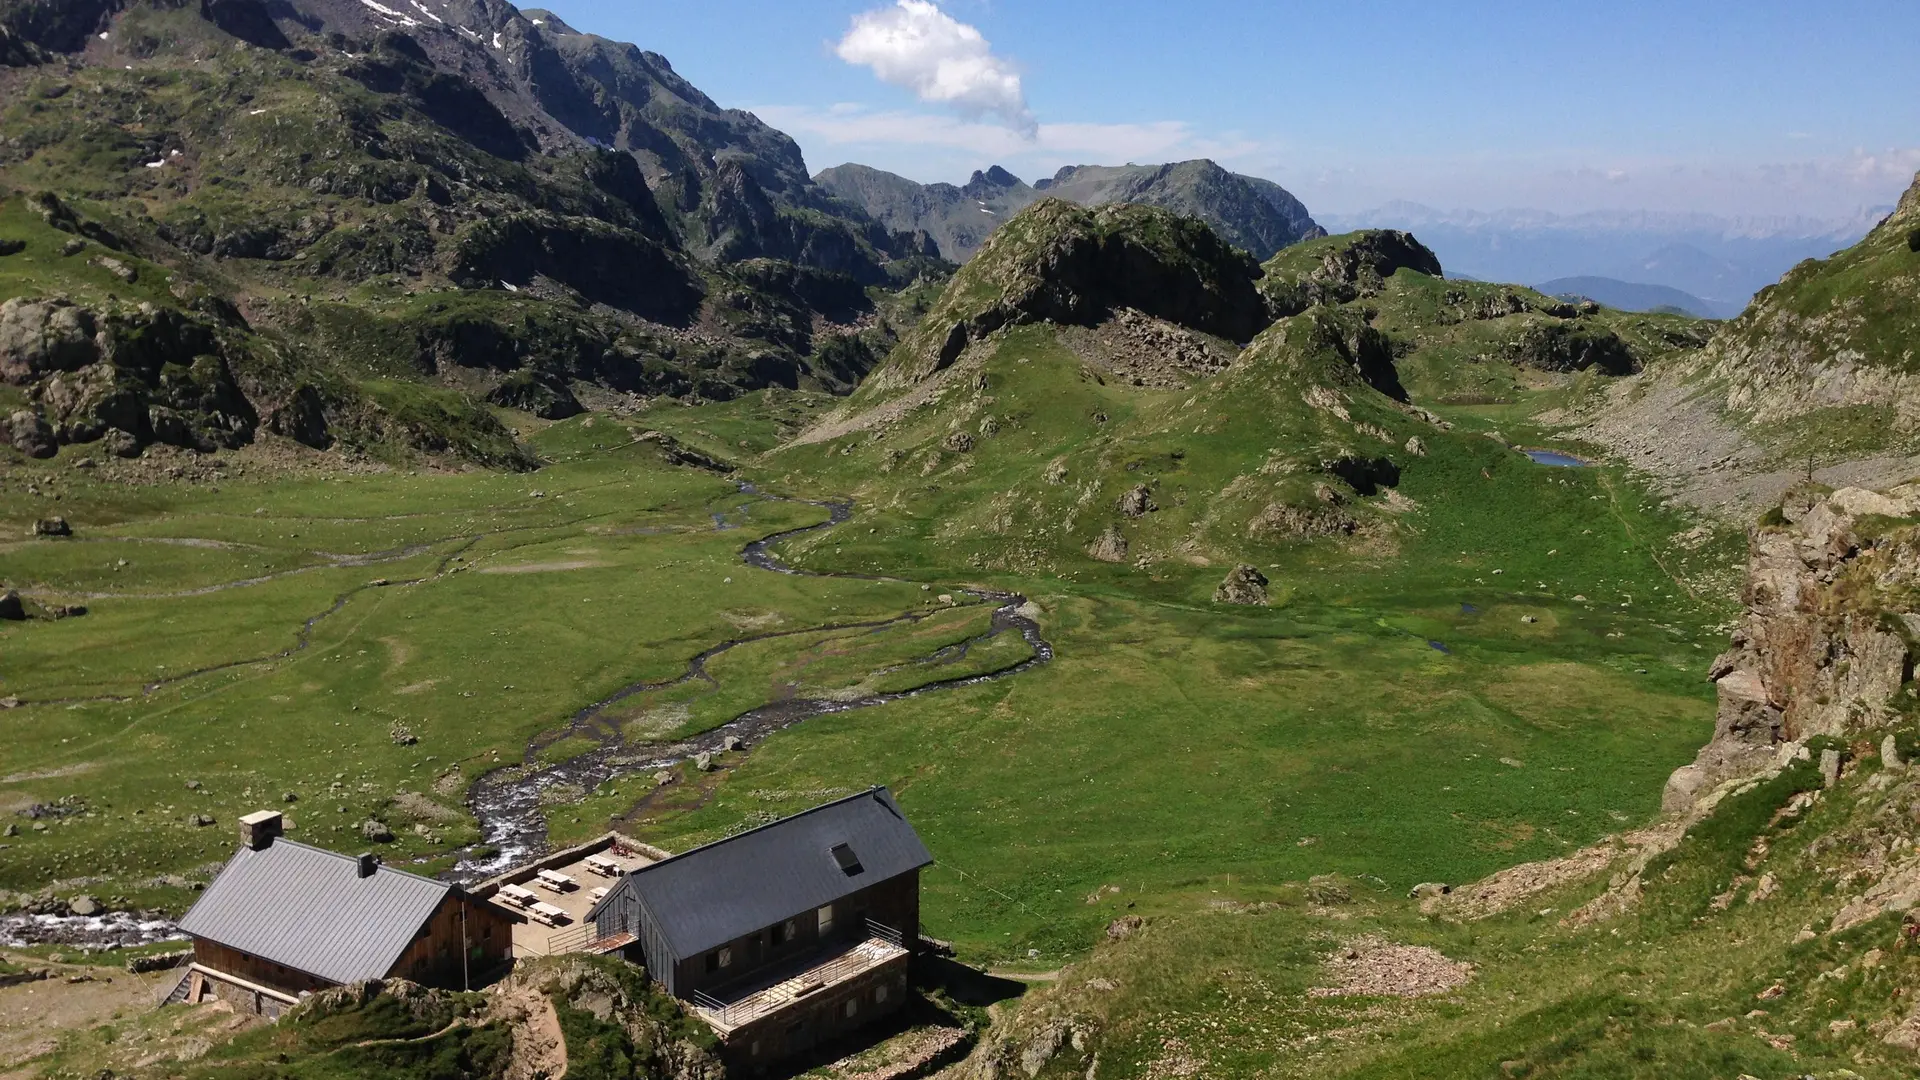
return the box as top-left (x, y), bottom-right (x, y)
top-left (169, 811), bottom-right (513, 1017)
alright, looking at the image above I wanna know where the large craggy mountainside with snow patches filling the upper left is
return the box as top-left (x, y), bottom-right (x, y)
top-left (0, 0), bottom-right (943, 467)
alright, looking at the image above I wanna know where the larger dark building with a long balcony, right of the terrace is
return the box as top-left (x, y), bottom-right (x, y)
top-left (588, 776), bottom-right (933, 1072)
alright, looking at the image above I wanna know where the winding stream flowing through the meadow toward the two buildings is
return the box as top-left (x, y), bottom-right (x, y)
top-left (447, 484), bottom-right (1054, 882)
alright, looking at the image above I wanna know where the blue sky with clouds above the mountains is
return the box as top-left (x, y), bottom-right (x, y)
top-left (529, 0), bottom-right (1920, 217)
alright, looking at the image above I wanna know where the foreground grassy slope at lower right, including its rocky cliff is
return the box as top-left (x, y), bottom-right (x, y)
top-left (958, 478), bottom-right (1920, 1080)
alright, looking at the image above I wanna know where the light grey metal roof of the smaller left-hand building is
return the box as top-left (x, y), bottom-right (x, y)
top-left (180, 840), bottom-right (453, 982)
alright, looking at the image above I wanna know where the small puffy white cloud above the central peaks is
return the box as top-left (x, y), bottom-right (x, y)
top-left (833, 0), bottom-right (1039, 138)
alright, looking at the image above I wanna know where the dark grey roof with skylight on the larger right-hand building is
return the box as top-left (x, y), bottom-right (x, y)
top-left (588, 788), bottom-right (933, 959)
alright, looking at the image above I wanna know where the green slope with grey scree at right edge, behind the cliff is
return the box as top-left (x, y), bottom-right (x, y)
top-left (1565, 168), bottom-right (1920, 519)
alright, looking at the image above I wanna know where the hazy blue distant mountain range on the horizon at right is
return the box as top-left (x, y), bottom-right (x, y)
top-left (1321, 202), bottom-right (1891, 311)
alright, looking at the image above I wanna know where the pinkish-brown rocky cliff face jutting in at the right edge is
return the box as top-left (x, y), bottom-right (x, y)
top-left (1663, 484), bottom-right (1920, 811)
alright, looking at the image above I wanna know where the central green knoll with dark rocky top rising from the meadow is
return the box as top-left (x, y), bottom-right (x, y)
top-left (774, 200), bottom-right (1512, 571)
